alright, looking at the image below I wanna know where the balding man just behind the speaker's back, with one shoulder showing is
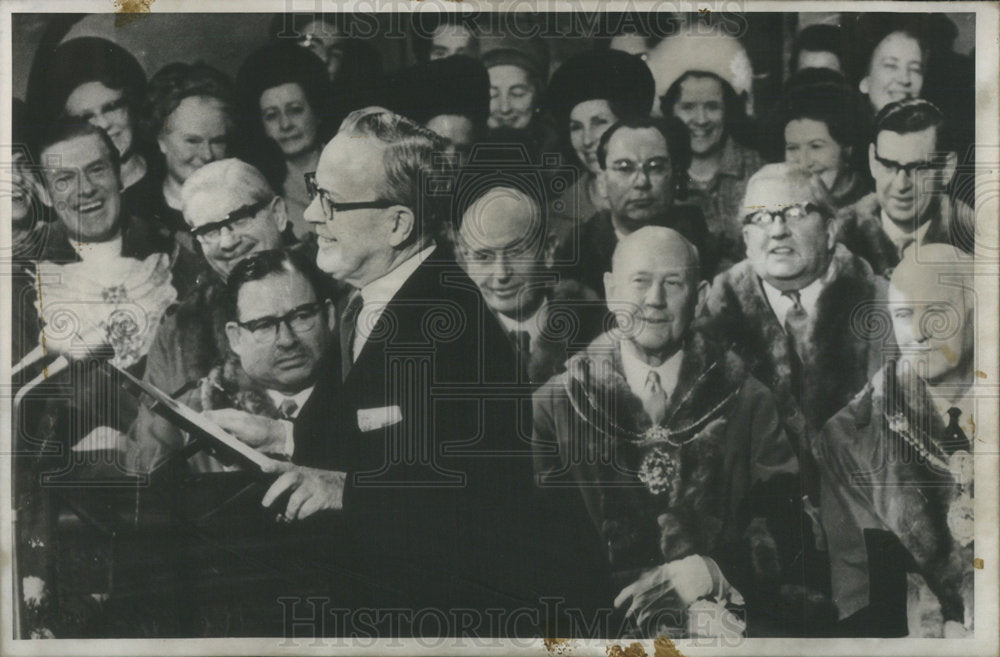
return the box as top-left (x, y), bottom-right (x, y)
top-left (457, 183), bottom-right (604, 386)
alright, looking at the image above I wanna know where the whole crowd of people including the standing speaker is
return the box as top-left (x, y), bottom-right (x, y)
top-left (11, 10), bottom-right (981, 638)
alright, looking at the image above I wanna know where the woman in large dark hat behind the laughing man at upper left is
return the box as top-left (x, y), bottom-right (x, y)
top-left (31, 37), bottom-right (156, 219)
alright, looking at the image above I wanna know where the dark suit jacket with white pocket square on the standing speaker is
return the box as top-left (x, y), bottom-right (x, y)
top-left (293, 248), bottom-right (584, 634)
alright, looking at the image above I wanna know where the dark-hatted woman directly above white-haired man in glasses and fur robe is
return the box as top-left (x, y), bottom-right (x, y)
top-left (775, 69), bottom-right (871, 210)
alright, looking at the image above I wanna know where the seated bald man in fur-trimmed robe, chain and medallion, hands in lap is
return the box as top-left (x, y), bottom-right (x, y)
top-left (533, 227), bottom-right (806, 638)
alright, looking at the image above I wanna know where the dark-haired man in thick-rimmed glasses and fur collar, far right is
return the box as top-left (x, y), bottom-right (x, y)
top-left (838, 98), bottom-right (976, 273)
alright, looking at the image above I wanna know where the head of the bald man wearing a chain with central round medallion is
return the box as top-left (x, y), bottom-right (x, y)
top-left (604, 226), bottom-right (708, 365)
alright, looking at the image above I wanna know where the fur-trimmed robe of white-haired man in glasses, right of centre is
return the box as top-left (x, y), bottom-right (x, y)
top-left (702, 244), bottom-right (895, 494)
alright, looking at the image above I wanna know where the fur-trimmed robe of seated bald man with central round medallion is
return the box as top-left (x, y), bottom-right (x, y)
top-left (533, 333), bottom-right (836, 635)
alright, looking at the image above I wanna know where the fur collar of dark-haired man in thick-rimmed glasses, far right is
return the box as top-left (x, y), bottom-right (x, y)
top-left (836, 193), bottom-right (976, 276)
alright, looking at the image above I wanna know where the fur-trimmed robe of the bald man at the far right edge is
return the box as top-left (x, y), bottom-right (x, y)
top-left (817, 363), bottom-right (974, 636)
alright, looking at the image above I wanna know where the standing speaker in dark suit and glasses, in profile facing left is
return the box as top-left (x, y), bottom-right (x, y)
top-left (217, 108), bottom-right (548, 635)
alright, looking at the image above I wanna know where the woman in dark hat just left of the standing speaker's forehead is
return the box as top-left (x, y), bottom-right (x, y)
top-left (236, 43), bottom-right (339, 240)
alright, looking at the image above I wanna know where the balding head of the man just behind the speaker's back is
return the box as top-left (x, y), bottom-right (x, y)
top-left (458, 185), bottom-right (553, 319)
